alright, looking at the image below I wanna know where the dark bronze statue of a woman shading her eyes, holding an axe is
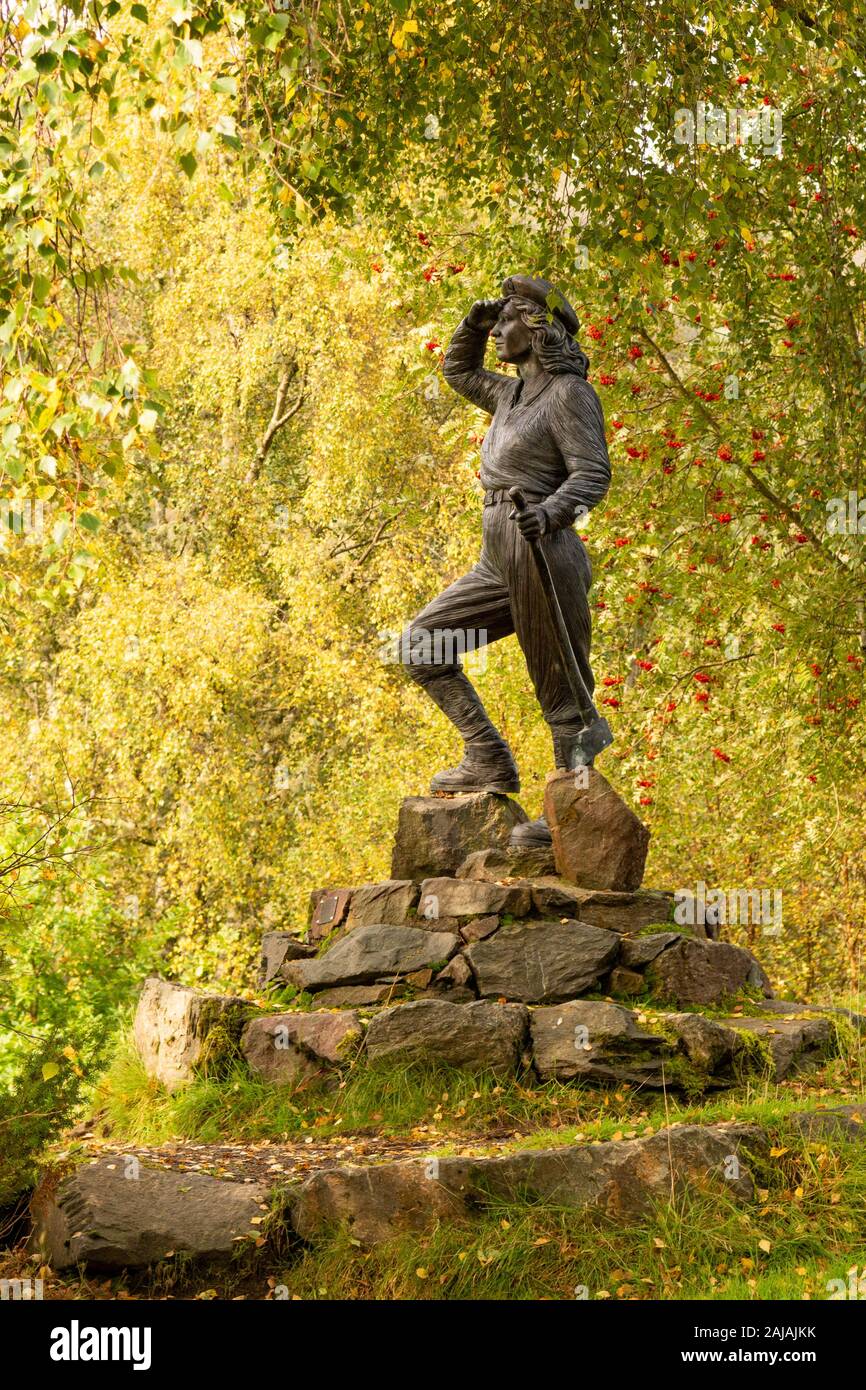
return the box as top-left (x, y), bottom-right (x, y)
top-left (403, 275), bottom-right (610, 845)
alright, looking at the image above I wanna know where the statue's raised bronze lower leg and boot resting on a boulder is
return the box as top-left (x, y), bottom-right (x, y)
top-left (423, 671), bottom-right (520, 792)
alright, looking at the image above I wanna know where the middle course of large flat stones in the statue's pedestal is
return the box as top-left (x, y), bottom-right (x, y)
top-left (279, 911), bottom-right (773, 1008)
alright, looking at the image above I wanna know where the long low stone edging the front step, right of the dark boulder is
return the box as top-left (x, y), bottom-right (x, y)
top-left (292, 1125), bottom-right (766, 1245)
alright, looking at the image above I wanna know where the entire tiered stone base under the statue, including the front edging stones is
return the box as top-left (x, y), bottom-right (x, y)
top-left (33, 770), bottom-right (866, 1269)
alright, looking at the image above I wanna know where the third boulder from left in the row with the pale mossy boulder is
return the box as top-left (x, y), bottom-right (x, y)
top-left (367, 999), bottom-right (528, 1072)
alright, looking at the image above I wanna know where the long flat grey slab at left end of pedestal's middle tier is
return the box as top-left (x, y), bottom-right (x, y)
top-left (288, 926), bottom-right (461, 991)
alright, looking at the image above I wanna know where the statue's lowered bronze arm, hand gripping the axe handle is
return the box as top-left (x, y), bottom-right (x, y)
top-left (542, 377), bottom-right (610, 531)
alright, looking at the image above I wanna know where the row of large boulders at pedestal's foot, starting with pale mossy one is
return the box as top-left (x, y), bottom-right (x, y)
top-left (135, 978), bottom-right (835, 1094)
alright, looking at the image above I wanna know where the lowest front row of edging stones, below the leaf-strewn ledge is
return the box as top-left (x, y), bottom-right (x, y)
top-left (35, 1104), bottom-right (866, 1270)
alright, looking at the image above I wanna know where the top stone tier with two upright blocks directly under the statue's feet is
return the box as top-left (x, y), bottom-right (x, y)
top-left (301, 795), bottom-right (733, 980)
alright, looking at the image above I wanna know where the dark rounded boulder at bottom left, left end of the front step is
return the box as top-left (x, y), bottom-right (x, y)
top-left (29, 1154), bottom-right (268, 1269)
